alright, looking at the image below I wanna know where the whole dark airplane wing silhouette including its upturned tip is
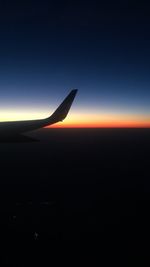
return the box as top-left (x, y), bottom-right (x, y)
top-left (0, 89), bottom-right (78, 135)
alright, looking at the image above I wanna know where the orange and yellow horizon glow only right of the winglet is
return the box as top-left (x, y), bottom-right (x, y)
top-left (48, 114), bottom-right (150, 128)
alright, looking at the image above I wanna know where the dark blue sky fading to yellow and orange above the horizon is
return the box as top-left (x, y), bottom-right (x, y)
top-left (0, 0), bottom-right (150, 127)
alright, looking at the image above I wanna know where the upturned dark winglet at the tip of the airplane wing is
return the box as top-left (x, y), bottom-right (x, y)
top-left (47, 89), bottom-right (78, 123)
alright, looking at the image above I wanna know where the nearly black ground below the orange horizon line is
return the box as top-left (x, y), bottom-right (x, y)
top-left (0, 129), bottom-right (150, 266)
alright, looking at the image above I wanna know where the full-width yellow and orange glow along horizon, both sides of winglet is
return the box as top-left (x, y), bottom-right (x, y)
top-left (0, 110), bottom-right (150, 128)
